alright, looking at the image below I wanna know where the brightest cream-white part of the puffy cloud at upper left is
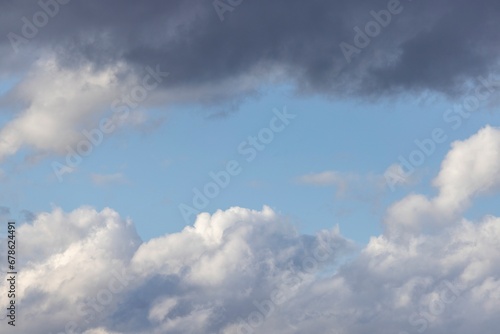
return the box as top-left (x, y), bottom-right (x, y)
top-left (0, 56), bottom-right (131, 160)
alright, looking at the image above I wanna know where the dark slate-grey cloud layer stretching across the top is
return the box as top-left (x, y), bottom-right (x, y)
top-left (1, 0), bottom-right (500, 102)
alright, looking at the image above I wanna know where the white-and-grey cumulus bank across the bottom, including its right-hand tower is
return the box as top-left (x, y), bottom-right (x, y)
top-left (0, 127), bottom-right (500, 334)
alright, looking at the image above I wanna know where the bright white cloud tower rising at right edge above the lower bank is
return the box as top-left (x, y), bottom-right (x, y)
top-left (385, 126), bottom-right (500, 233)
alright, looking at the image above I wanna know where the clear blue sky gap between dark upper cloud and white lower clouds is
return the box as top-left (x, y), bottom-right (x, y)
top-left (4, 83), bottom-right (498, 244)
